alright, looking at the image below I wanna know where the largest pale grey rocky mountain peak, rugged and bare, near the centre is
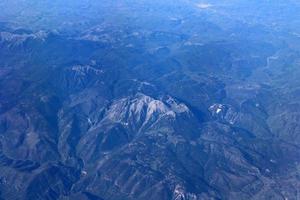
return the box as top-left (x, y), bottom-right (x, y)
top-left (106, 93), bottom-right (190, 132)
